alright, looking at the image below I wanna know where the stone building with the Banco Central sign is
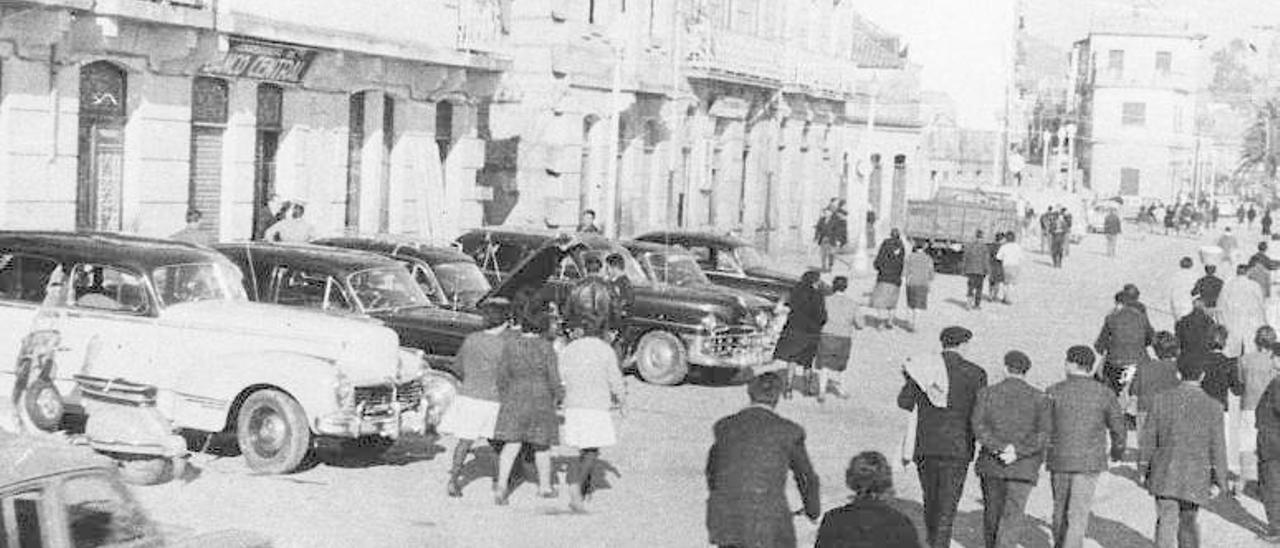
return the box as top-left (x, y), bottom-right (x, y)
top-left (0, 0), bottom-right (509, 239)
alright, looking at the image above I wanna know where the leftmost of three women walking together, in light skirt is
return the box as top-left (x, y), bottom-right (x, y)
top-left (436, 306), bottom-right (512, 497)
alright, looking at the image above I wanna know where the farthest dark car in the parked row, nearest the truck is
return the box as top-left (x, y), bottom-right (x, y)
top-left (635, 230), bottom-right (800, 302)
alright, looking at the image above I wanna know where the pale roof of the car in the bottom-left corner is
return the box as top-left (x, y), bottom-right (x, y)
top-left (0, 430), bottom-right (115, 488)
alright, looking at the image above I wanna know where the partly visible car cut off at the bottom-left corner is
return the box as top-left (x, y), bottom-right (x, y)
top-left (0, 433), bottom-right (271, 548)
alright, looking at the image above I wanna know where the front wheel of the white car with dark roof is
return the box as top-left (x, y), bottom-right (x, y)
top-left (236, 389), bottom-right (311, 474)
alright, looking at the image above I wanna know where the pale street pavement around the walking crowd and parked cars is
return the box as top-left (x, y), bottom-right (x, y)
top-left (136, 225), bottom-right (1263, 548)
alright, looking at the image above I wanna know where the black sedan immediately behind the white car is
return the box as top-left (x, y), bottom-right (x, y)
top-left (214, 242), bottom-right (484, 374)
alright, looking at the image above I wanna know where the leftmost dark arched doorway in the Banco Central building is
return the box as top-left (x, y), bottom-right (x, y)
top-left (76, 61), bottom-right (128, 230)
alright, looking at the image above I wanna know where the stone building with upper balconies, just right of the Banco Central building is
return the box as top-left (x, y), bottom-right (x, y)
top-left (481, 0), bottom-right (920, 252)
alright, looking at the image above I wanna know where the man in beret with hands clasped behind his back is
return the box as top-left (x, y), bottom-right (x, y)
top-left (972, 351), bottom-right (1053, 548)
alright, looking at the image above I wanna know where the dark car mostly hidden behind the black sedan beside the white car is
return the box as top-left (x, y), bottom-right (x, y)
top-left (311, 234), bottom-right (493, 310)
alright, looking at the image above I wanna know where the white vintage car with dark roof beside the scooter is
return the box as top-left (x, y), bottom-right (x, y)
top-left (0, 232), bottom-right (426, 474)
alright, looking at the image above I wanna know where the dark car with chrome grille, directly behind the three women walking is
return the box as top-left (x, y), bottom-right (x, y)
top-left (458, 228), bottom-right (772, 384)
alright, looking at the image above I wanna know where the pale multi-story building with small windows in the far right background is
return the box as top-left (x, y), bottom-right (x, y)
top-left (1074, 10), bottom-right (1203, 201)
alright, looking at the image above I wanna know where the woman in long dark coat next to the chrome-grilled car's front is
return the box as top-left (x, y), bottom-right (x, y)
top-left (773, 270), bottom-right (827, 398)
